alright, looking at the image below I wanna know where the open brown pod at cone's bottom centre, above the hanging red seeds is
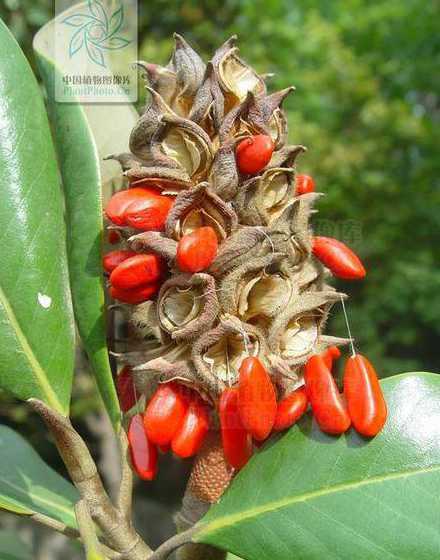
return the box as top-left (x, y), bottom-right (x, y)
top-left (191, 314), bottom-right (268, 400)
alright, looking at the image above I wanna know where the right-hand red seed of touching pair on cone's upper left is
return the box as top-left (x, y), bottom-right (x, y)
top-left (124, 195), bottom-right (173, 231)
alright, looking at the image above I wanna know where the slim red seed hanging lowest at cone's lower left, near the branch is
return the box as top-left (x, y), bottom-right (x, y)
top-left (127, 414), bottom-right (157, 480)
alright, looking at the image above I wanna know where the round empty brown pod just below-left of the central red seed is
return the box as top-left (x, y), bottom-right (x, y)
top-left (157, 273), bottom-right (219, 342)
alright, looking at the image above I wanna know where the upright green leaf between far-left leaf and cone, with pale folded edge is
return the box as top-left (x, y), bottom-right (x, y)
top-left (34, 7), bottom-right (137, 429)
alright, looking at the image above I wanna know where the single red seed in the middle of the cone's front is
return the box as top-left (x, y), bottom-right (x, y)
top-left (176, 226), bottom-right (218, 272)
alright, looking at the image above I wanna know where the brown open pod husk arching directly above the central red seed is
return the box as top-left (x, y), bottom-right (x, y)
top-left (165, 182), bottom-right (238, 242)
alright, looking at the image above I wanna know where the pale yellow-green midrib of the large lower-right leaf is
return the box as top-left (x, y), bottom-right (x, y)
top-left (194, 465), bottom-right (440, 541)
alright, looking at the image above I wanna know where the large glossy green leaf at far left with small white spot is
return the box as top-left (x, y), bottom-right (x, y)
top-left (0, 21), bottom-right (74, 414)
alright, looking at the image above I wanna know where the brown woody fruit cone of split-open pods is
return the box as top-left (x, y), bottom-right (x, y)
top-left (107, 35), bottom-right (352, 508)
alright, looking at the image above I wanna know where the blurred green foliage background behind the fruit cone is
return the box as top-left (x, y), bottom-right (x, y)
top-left (0, 0), bottom-right (440, 557)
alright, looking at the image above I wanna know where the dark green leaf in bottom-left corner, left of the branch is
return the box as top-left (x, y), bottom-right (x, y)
top-left (0, 426), bottom-right (79, 527)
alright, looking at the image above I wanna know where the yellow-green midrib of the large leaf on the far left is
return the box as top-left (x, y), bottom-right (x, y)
top-left (0, 287), bottom-right (64, 414)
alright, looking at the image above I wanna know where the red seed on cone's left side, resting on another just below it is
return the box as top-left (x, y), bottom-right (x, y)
top-left (110, 253), bottom-right (164, 290)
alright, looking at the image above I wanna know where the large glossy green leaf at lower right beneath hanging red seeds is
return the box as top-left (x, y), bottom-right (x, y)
top-left (198, 373), bottom-right (440, 560)
